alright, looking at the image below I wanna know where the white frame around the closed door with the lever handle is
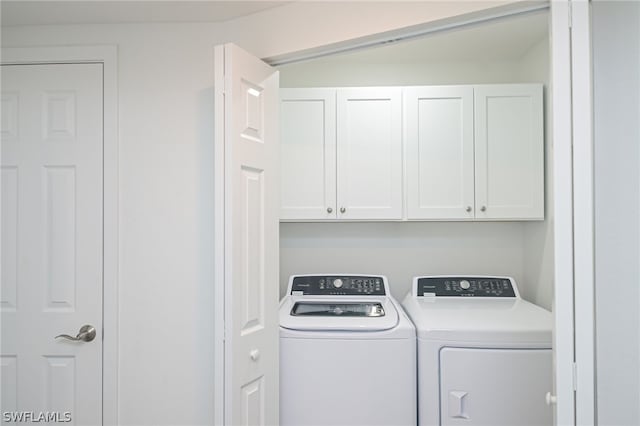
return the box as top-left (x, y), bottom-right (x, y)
top-left (2, 45), bottom-right (119, 425)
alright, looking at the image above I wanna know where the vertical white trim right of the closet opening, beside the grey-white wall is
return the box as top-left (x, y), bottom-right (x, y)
top-left (559, 0), bottom-right (597, 425)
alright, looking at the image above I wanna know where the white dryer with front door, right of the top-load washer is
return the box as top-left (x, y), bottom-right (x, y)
top-left (403, 276), bottom-right (553, 426)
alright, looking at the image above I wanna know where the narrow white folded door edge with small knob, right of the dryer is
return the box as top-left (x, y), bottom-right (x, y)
top-left (548, 0), bottom-right (576, 425)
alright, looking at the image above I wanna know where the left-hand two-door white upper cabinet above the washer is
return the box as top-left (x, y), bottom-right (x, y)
top-left (280, 88), bottom-right (402, 220)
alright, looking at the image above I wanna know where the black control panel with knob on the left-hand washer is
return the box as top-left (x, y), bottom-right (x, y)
top-left (291, 275), bottom-right (386, 296)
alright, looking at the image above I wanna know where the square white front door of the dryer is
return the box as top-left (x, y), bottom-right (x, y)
top-left (440, 348), bottom-right (553, 426)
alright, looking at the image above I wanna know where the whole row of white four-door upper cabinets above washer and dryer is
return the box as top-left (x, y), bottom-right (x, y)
top-left (281, 84), bottom-right (544, 220)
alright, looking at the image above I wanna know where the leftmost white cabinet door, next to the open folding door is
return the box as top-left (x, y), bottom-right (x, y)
top-left (280, 89), bottom-right (337, 220)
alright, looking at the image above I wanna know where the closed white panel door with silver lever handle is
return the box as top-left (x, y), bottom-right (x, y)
top-left (0, 64), bottom-right (103, 425)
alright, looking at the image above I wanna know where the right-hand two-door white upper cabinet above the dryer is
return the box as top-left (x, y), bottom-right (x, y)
top-left (404, 84), bottom-right (544, 220)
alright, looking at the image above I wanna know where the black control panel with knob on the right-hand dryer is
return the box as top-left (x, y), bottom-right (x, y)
top-left (416, 276), bottom-right (516, 297)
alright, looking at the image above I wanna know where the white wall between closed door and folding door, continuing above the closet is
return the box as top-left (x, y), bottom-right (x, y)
top-left (2, 1), bottom-right (516, 425)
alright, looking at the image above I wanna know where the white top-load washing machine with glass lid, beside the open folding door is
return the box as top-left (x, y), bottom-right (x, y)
top-left (280, 274), bottom-right (417, 426)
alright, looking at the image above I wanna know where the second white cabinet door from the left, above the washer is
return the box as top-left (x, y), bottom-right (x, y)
top-left (337, 88), bottom-right (402, 220)
